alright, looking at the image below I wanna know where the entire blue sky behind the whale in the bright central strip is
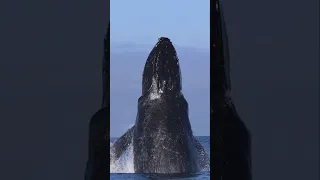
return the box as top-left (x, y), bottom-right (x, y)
top-left (110, 0), bottom-right (210, 137)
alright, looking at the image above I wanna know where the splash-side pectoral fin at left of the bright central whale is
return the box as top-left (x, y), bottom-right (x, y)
top-left (110, 126), bottom-right (134, 159)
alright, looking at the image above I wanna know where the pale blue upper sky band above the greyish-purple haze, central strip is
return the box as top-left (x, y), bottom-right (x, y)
top-left (110, 0), bottom-right (210, 48)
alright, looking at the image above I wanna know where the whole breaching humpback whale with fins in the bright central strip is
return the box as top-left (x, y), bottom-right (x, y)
top-left (110, 37), bottom-right (209, 174)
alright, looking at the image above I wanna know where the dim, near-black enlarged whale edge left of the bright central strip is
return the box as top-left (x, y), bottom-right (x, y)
top-left (85, 23), bottom-right (110, 180)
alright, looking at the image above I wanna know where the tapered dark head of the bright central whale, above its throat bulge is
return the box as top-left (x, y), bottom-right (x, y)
top-left (142, 37), bottom-right (182, 95)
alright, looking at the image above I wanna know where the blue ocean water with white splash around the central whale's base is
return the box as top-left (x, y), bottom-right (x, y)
top-left (110, 136), bottom-right (210, 180)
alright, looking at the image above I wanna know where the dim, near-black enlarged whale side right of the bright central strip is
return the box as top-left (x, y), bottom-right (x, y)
top-left (210, 1), bottom-right (252, 180)
